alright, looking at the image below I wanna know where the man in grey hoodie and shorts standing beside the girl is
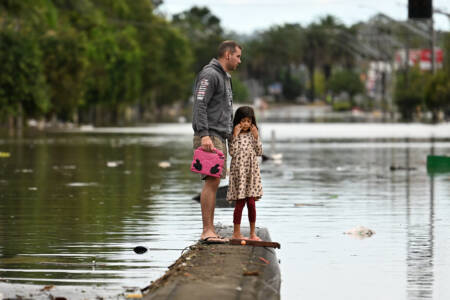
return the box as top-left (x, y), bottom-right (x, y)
top-left (192, 41), bottom-right (242, 243)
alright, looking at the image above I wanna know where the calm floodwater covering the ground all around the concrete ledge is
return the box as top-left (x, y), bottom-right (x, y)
top-left (0, 123), bottom-right (450, 300)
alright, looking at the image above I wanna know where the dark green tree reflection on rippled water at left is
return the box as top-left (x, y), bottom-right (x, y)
top-left (0, 135), bottom-right (190, 300)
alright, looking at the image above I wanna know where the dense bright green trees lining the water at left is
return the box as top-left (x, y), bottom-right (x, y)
top-left (0, 0), bottom-right (193, 122)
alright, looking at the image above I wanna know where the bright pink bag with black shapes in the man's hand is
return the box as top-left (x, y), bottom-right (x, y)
top-left (191, 147), bottom-right (225, 177)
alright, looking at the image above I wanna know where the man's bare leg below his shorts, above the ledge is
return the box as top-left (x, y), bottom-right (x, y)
top-left (200, 177), bottom-right (220, 239)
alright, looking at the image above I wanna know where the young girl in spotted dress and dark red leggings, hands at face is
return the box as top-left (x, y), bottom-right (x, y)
top-left (227, 106), bottom-right (263, 241)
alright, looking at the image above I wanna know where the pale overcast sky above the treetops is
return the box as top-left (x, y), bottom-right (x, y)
top-left (159, 0), bottom-right (450, 34)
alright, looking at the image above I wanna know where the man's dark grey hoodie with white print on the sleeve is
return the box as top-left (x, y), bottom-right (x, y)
top-left (192, 58), bottom-right (233, 139)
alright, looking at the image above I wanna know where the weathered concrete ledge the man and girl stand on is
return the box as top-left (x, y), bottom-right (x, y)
top-left (143, 227), bottom-right (281, 300)
